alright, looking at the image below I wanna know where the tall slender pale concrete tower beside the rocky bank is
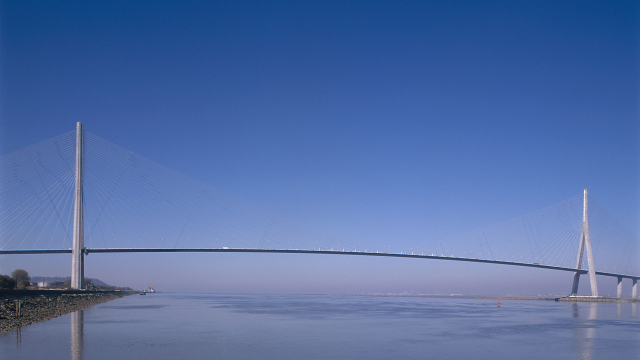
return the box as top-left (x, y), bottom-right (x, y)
top-left (71, 122), bottom-right (84, 289)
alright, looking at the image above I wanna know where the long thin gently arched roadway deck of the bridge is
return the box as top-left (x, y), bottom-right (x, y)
top-left (0, 248), bottom-right (640, 280)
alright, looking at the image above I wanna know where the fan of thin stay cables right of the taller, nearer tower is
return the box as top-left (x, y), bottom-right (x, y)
top-left (84, 133), bottom-right (352, 249)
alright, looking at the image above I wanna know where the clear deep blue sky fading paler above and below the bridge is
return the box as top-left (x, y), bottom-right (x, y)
top-left (0, 1), bottom-right (640, 294)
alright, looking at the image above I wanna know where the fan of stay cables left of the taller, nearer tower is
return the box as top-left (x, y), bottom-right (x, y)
top-left (0, 131), bottom-right (76, 250)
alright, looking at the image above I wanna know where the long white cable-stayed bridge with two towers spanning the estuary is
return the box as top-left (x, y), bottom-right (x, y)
top-left (0, 123), bottom-right (640, 299)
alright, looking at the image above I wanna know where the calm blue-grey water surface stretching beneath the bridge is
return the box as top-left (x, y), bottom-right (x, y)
top-left (0, 294), bottom-right (640, 360)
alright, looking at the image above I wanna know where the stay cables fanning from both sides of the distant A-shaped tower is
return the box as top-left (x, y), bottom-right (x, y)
top-left (402, 195), bottom-right (640, 274)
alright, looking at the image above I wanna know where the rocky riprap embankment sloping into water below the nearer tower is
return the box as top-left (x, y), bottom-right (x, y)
top-left (0, 290), bottom-right (132, 333)
